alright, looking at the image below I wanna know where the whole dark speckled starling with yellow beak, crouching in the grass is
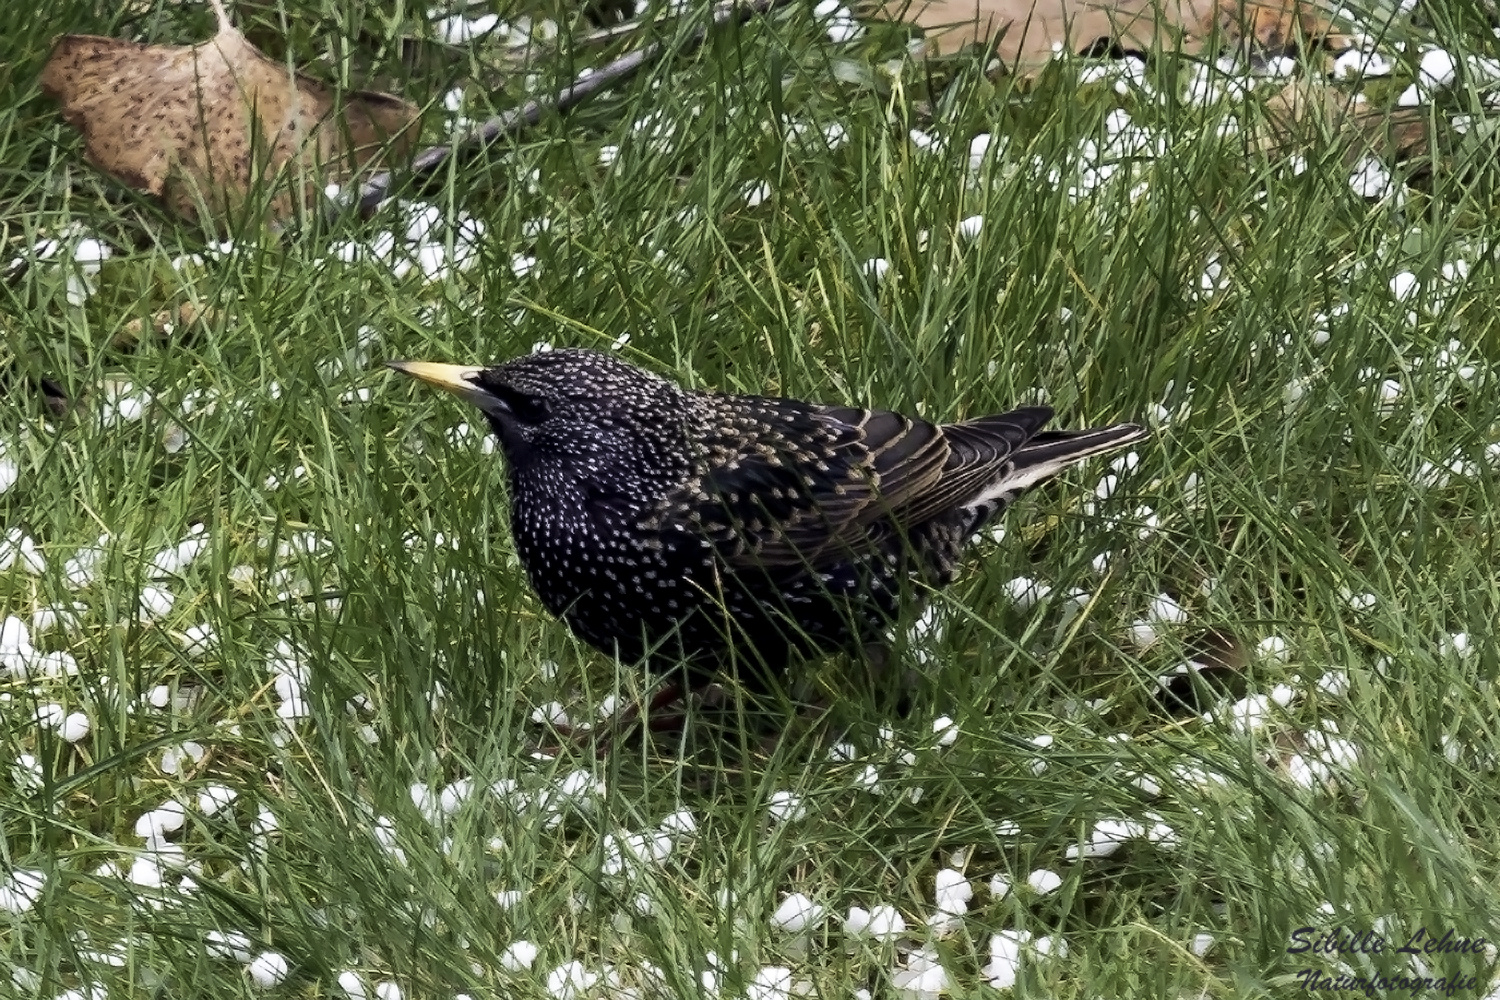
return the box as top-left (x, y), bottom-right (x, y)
top-left (390, 349), bottom-right (1146, 687)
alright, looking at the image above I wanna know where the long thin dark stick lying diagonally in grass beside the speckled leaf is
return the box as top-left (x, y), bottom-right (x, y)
top-left (357, 0), bottom-right (788, 216)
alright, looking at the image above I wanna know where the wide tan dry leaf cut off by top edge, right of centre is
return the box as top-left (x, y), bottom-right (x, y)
top-left (882, 0), bottom-right (1344, 73)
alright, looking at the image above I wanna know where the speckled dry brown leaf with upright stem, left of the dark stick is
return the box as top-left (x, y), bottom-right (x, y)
top-left (42, 0), bottom-right (417, 220)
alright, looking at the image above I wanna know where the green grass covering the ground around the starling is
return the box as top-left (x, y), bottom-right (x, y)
top-left (0, 0), bottom-right (1500, 997)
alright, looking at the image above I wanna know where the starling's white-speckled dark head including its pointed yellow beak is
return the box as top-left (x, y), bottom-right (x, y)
top-left (389, 349), bottom-right (687, 479)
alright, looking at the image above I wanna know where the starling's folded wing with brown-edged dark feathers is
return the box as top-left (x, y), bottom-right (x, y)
top-left (689, 399), bottom-right (950, 568)
